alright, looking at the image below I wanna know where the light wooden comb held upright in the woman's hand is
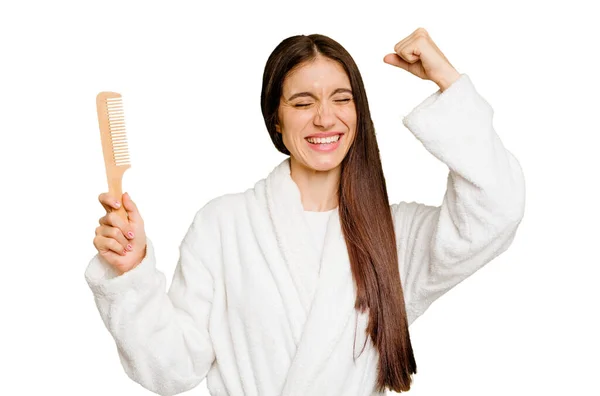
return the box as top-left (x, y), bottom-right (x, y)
top-left (96, 92), bottom-right (131, 220)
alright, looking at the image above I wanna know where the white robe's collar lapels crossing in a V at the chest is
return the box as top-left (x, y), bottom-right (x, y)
top-left (266, 158), bottom-right (356, 396)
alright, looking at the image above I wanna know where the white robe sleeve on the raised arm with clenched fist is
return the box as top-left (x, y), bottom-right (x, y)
top-left (391, 74), bottom-right (525, 324)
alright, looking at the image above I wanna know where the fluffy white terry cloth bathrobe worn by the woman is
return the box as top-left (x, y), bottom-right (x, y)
top-left (85, 74), bottom-right (525, 396)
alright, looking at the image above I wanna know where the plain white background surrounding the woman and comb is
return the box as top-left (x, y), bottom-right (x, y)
top-left (0, 0), bottom-right (600, 396)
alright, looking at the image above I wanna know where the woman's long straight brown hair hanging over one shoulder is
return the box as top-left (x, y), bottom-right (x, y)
top-left (260, 34), bottom-right (417, 392)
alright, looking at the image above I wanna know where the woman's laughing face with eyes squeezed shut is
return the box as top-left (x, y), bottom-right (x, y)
top-left (276, 56), bottom-right (356, 171)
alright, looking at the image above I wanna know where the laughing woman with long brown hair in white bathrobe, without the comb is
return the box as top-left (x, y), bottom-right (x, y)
top-left (86, 29), bottom-right (525, 396)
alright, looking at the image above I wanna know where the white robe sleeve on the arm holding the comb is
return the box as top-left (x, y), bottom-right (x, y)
top-left (85, 211), bottom-right (215, 395)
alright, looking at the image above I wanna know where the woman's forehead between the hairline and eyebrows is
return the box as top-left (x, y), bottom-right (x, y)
top-left (283, 56), bottom-right (350, 93)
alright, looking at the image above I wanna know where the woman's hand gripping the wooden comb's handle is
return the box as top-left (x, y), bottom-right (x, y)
top-left (94, 193), bottom-right (146, 275)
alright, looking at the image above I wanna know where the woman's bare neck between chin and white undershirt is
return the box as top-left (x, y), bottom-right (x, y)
top-left (290, 157), bottom-right (341, 212)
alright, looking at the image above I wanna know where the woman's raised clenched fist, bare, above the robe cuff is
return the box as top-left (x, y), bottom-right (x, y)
top-left (383, 28), bottom-right (460, 91)
